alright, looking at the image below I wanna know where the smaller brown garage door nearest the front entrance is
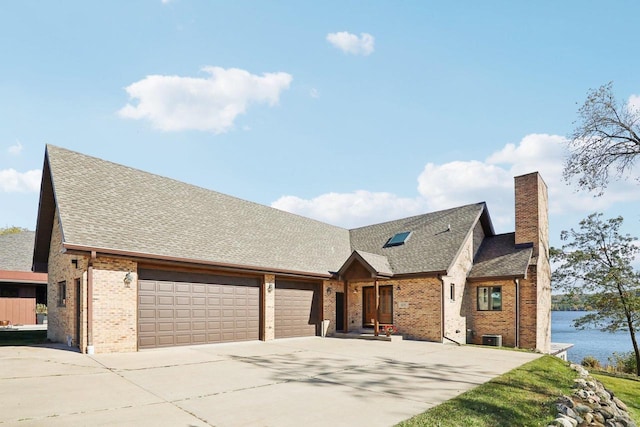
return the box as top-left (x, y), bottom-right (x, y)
top-left (275, 280), bottom-right (320, 338)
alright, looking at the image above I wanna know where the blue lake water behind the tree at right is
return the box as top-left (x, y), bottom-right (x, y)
top-left (551, 311), bottom-right (640, 363)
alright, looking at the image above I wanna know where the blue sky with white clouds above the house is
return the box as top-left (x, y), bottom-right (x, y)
top-left (0, 0), bottom-right (640, 249)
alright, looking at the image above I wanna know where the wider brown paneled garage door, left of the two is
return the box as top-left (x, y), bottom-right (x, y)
top-left (138, 269), bottom-right (260, 349)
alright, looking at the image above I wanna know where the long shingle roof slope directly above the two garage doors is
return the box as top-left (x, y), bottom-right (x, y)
top-left (41, 145), bottom-right (351, 275)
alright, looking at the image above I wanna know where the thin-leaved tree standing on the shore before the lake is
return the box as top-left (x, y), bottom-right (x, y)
top-left (552, 213), bottom-right (640, 376)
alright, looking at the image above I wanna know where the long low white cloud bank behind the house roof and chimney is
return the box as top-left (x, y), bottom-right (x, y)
top-left (272, 134), bottom-right (640, 232)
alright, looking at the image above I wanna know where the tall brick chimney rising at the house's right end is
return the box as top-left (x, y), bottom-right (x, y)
top-left (514, 172), bottom-right (549, 259)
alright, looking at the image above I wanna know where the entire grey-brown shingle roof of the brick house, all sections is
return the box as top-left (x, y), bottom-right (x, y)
top-left (34, 145), bottom-right (526, 276)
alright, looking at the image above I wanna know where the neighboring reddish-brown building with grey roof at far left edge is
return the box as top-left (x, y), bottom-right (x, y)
top-left (0, 231), bottom-right (47, 325)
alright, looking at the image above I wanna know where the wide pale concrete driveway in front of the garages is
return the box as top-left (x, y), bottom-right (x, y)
top-left (0, 338), bottom-right (538, 427)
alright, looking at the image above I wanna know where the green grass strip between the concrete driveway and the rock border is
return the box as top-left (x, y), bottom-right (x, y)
top-left (398, 356), bottom-right (577, 427)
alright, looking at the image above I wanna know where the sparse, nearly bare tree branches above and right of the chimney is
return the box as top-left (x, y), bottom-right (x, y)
top-left (563, 82), bottom-right (640, 195)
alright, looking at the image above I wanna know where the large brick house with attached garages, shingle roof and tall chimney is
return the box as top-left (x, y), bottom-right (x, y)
top-left (33, 146), bottom-right (551, 353)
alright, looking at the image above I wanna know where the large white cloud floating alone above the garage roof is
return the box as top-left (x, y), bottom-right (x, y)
top-left (118, 67), bottom-right (293, 134)
